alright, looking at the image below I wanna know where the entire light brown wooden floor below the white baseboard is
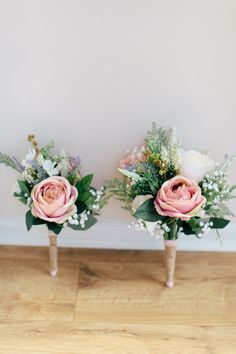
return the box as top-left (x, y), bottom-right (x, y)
top-left (0, 247), bottom-right (236, 354)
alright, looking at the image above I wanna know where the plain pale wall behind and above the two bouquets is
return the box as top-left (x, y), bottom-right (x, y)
top-left (0, 0), bottom-right (236, 248)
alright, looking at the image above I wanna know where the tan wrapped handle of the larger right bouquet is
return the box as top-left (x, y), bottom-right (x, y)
top-left (165, 240), bottom-right (176, 288)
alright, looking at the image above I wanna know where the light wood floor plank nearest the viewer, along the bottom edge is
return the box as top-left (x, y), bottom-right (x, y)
top-left (0, 321), bottom-right (236, 354)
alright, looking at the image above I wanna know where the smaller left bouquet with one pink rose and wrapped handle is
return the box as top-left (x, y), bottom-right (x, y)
top-left (0, 135), bottom-right (106, 276)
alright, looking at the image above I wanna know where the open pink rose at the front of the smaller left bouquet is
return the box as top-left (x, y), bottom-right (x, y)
top-left (31, 176), bottom-right (78, 224)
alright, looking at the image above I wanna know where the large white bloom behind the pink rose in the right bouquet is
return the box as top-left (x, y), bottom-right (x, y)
top-left (179, 149), bottom-right (215, 183)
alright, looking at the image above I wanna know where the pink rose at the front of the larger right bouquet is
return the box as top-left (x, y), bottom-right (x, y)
top-left (155, 176), bottom-right (205, 220)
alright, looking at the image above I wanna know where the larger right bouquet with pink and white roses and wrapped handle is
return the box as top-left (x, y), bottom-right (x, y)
top-left (108, 124), bottom-right (236, 287)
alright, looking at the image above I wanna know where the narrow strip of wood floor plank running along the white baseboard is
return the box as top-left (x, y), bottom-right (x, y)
top-left (0, 246), bottom-right (236, 265)
